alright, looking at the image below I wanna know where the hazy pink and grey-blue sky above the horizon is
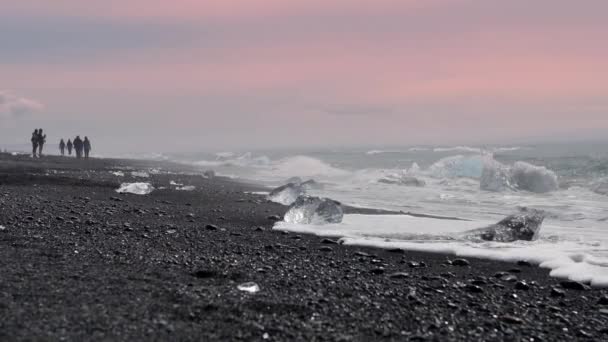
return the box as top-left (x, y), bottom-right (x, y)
top-left (0, 0), bottom-right (608, 153)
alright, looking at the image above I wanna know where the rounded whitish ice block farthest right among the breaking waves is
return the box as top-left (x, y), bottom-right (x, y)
top-left (511, 161), bottom-right (559, 193)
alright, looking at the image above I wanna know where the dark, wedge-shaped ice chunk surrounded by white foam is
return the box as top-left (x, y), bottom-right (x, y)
top-left (463, 209), bottom-right (545, 242)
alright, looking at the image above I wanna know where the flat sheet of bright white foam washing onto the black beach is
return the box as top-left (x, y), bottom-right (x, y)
top-left (274, 215), bottom-right (608, 287)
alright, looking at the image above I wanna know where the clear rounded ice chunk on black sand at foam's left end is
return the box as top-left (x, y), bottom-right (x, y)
top-left (284, 196), bottom-right (344, 224)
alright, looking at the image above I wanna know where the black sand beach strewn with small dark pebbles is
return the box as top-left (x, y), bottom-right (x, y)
top-left (0, 154), bottom-right (608, 341)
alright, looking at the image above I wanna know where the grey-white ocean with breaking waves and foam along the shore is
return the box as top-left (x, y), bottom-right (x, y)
top-left (169, 142), bottom-right (608, 286)
